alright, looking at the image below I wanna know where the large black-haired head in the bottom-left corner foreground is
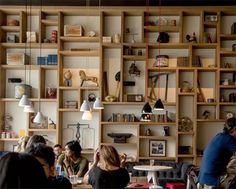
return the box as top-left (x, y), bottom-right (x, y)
top-left (0, 152), bottom-right (47, 189)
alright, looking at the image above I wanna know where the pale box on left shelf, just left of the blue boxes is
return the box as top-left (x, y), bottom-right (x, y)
top-left (7, 53), bottom-right (29, 65)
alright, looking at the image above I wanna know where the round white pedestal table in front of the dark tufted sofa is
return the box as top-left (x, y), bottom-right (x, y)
top-left (134, 165), bottom-right (172, 189)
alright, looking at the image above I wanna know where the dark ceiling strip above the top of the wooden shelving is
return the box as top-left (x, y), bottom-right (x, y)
top-left (0, 0), bottom-right (236, 6)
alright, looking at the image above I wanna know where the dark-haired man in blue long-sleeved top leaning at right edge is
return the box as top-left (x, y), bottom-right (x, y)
top-left (198, 118), bottom-right (236, 189)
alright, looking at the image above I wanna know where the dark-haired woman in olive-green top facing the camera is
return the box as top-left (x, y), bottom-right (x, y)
top-left (58, 140), bottom-right (88, 177)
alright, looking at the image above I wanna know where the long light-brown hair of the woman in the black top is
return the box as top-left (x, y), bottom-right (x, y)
top-left (99, 145), bottom-right (120, 167)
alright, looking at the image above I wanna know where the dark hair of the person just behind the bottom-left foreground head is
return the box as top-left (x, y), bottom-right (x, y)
top-left (25, 143), bottom-right (55, 167)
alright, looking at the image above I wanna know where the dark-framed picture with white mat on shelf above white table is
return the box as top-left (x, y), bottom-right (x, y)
top-left (149, 140), bottom-right (166, 157)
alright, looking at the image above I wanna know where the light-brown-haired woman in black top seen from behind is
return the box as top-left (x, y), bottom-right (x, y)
top-left (84, 145), bottom-right (129, 189)
